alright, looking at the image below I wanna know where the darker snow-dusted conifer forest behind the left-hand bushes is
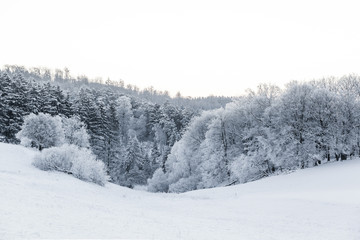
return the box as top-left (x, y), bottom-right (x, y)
top-left (0, 67), bottom-right (197, 187)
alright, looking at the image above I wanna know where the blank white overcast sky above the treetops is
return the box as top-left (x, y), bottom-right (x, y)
top-left (0, 0), bottom-right (360, 96)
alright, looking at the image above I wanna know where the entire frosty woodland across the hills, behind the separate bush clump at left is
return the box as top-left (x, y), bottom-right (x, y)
top-left (0, 66), bottom-right (360, 192)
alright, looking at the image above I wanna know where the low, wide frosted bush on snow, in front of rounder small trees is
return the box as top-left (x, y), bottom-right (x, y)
top-left (33, 145), bottom-right (108, 186)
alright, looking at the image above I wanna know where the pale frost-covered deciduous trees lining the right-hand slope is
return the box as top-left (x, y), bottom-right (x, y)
top-left (149, 74), bottom-right (360, 192)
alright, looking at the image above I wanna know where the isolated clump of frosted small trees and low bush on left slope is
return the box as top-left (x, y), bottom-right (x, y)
top-left (16, 113), bottom-right (108, 186)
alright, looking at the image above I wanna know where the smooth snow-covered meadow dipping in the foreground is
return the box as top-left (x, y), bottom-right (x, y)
top-left (0, 144), bottom-right (360, 240)
